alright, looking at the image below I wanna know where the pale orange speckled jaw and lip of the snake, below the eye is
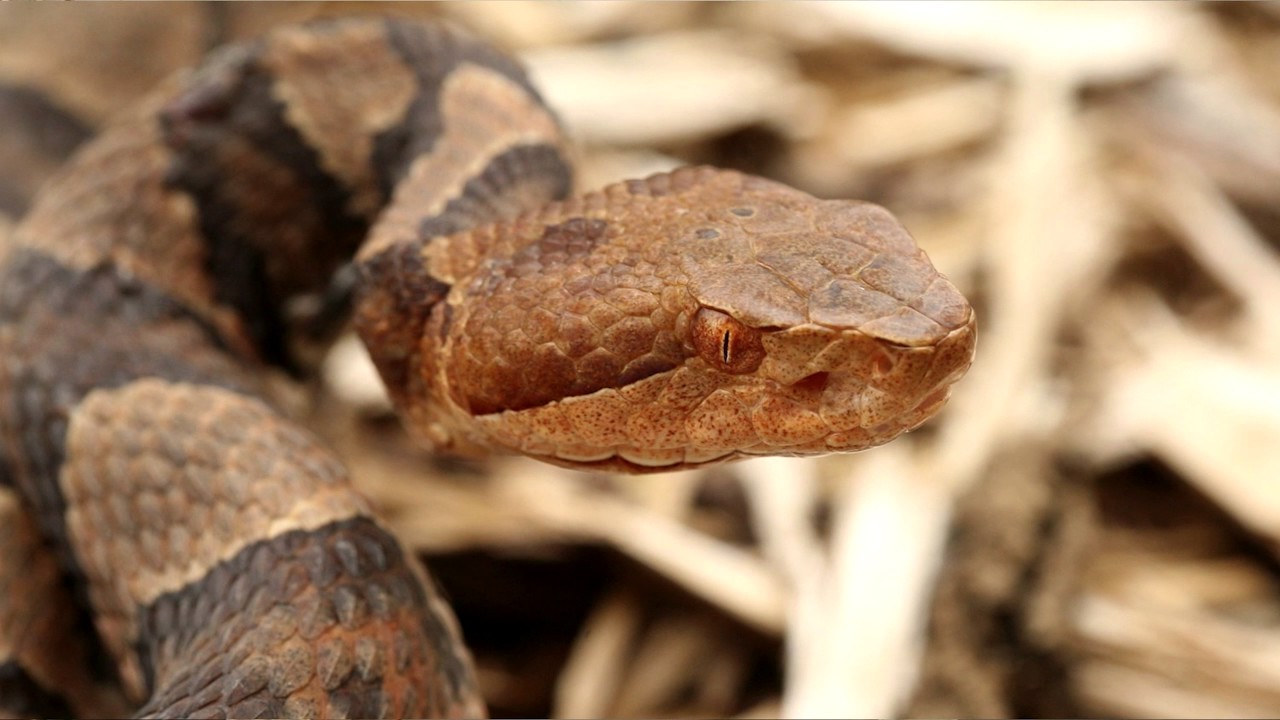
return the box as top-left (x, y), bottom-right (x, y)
top-left (477, 313), bottom-right (974, 473)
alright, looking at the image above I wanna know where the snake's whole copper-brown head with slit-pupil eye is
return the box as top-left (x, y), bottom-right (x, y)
top-left (371, 168), bottom-right (974, 471)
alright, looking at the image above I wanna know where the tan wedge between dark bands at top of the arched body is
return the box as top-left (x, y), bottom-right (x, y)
top-left (262, 23), bottom-right (417, 218)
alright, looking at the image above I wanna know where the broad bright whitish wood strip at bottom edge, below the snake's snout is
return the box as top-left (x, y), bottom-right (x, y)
top-left (783, 443), bottom-right (951, 717)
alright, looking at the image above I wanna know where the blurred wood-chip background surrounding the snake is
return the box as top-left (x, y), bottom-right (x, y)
top-left (0, 3), bottom-right (1280, 717)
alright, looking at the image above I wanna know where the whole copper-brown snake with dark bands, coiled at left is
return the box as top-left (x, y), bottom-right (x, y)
top-left (0, 18), bottom-right (975, 717)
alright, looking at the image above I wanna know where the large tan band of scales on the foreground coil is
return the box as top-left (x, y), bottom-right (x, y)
top-left (59, 379), bottom-right (389, 691)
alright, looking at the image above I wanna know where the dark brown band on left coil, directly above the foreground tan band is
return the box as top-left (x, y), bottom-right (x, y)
top-left (0, 250), bottom-right (257, 564)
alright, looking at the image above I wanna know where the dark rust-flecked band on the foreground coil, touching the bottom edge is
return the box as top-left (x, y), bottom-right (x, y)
top-left (133, 519), bottom-right (480, 717)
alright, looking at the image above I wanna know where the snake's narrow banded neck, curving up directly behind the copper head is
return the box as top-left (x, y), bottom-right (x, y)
top-left (340, 25), bottom-right (573, 448)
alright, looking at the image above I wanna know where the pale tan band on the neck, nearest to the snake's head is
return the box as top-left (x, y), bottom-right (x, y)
top-left (358, 64), bottom-right (567, 262)
